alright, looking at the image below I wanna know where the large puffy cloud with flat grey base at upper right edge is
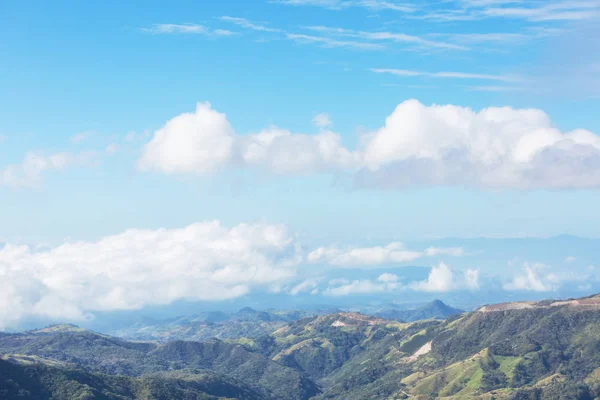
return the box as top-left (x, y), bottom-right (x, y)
top-left (357, 100), bottom-right (600, 189)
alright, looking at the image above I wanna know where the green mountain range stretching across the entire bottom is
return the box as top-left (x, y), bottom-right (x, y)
top-left (0, 295), bottom-right (600, 400)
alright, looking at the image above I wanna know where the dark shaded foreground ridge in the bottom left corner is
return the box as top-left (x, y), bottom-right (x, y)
top-left (0, 357), bottom-right (263, 400)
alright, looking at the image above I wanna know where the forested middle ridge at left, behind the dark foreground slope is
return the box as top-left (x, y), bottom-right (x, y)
top-left (0, 328), bottom-right (318, 400)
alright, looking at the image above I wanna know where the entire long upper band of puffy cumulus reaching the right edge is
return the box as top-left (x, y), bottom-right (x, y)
top-left (138, 100), bottom-right (600, 189)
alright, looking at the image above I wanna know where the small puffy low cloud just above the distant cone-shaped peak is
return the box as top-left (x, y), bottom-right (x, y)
top-left (410, 262), bottom-right (479, 293)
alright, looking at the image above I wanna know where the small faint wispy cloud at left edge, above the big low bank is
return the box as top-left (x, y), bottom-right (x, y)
top-left (0, 151), bottom-right (98, 189)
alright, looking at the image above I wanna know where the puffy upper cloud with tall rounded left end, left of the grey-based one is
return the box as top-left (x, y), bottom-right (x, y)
top-left (138, 103), bottom-right (356, 174)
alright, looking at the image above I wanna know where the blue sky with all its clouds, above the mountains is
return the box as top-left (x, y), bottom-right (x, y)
top-left (0, 0), bottom-right (600, 329)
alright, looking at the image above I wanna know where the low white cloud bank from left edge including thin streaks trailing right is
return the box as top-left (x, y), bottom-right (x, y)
top-left (0, 216), bottom-right (478, 330)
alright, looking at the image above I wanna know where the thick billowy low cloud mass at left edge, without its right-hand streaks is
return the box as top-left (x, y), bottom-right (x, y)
top-left (0, 221), bottom-right (301, 329)
